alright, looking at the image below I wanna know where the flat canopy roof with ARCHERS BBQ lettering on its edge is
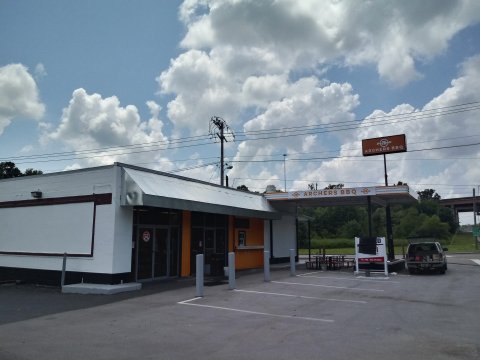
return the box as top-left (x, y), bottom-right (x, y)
top-left (265, 185), bottom-right (417, 210)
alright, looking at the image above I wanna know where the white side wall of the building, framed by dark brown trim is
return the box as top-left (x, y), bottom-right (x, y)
top-left (0, 166), bottom-right (123, 273)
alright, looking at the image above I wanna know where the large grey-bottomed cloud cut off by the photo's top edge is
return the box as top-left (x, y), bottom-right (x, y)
top-left (176, 0), bottom-right (480, 86)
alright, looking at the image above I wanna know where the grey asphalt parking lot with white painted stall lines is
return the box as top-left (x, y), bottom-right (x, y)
top-left (0, 254), bottom-right (480, 360)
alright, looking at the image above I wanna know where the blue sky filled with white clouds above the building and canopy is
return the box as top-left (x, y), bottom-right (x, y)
top-left (0, 0), bottom-right (480, 222)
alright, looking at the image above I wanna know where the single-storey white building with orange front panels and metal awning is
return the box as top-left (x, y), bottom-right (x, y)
top-left (0, 163), bottom-right (296, 285)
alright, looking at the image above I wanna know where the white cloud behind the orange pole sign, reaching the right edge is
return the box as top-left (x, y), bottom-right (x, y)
top-left (293, 56), bottom-right (480, 197)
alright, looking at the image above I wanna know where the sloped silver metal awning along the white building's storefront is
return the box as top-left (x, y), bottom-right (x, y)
top-left (119, 164), bottom-right (280, 219)
